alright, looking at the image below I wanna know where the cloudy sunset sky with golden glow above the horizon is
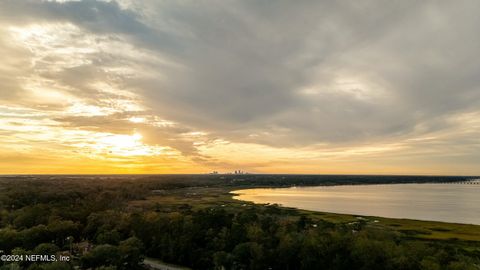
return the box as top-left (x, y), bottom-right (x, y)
top-left (0, 0), bottom-right (480, 175)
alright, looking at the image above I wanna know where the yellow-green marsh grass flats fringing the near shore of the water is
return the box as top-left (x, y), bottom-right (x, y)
top-left (129, 187), bottom-right (480, 243)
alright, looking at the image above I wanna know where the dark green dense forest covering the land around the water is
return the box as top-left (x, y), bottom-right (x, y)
top-left (0, 175), bottom-right (480, 270)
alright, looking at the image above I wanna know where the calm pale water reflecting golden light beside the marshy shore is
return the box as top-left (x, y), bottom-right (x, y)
top-left (233, 184), bottom-right (480, 225)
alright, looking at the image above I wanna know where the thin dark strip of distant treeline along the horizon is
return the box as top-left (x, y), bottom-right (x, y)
top-left (0, 174), bottom-right (472, 189)
